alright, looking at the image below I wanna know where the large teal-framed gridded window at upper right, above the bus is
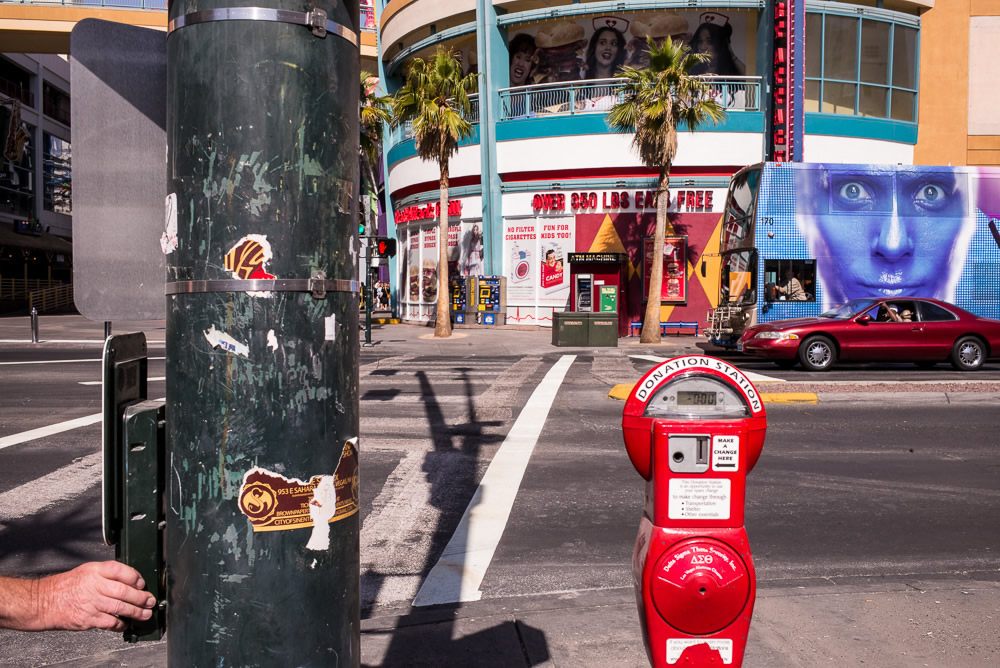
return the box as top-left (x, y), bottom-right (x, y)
top-left (804, 10), bottom-right (918, 123)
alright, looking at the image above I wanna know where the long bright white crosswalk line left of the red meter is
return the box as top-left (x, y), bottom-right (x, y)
top-left (413, 355), bottom-right (576, 606)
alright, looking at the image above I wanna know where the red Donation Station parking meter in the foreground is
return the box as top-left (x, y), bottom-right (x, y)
top-left (622, 355), bottom-right (767, 667)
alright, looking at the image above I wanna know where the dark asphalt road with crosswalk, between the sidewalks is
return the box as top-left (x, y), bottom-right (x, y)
top-left (0, 337), bottom-right (1000, 666)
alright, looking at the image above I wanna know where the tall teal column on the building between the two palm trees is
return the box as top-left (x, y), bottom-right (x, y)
top-left (476, 0), bottom-right (510, 274)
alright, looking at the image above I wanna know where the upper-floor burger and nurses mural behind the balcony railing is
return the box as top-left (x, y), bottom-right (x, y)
top-left (507, 10), bottom-right (748, 86)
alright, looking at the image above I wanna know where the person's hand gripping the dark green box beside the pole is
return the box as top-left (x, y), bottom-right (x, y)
top-left (38, 561), bottom-right (156, 631)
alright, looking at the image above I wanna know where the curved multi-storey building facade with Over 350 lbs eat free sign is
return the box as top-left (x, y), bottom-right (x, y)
top-left (376, 0), bottom-right (944, 326)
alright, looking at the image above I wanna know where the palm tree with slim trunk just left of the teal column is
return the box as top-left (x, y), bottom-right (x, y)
top-left (392, 47), bottom-right (477, 336)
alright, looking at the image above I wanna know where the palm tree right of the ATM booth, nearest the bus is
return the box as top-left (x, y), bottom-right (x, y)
top-left (607, 37), bottom-right (726, 343)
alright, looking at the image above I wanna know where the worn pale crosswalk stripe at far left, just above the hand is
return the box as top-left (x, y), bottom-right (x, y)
top-left (0, 452), bottom-right (103, 526)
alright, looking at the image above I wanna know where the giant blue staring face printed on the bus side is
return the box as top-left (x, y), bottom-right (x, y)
top-left (796, 165), bottom-right (975, 304)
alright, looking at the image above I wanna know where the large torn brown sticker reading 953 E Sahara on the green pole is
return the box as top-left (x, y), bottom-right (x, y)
top-left (239, 438), bottom-right (359, 536)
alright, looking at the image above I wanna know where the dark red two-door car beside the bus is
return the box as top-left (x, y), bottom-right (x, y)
top-left (737, 297), bottom-right (1000, 371)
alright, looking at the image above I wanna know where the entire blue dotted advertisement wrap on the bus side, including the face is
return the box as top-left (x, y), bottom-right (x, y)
top-left (756, 164), bottom-right (1000, 320)
